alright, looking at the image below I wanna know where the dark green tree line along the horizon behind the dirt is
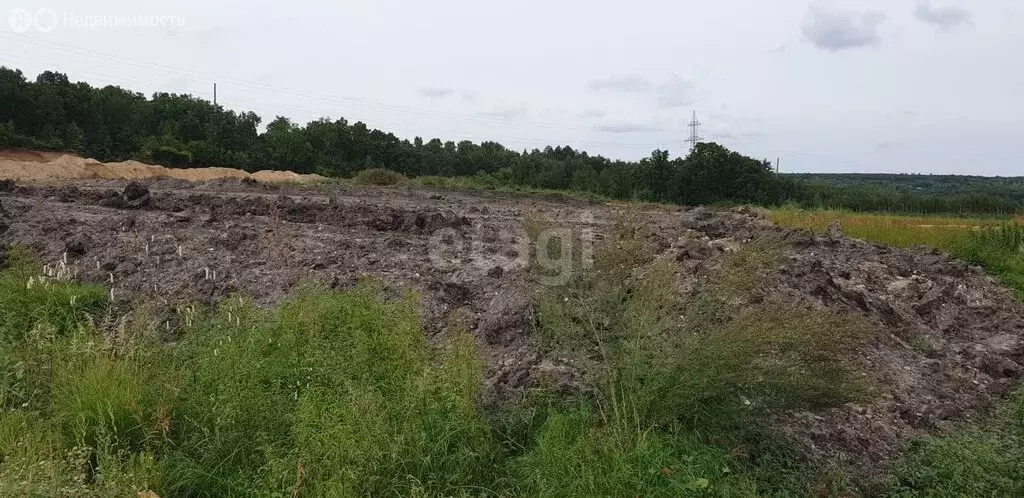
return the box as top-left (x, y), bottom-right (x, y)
top-left (0, 67), bottom-right (1020, 213)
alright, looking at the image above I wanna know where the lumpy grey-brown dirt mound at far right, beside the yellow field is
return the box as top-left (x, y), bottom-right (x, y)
top-left (763, 233), bottom-right (1024, 467)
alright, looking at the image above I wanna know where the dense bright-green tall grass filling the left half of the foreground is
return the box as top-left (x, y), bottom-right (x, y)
top-left (0, 255), bottom-right (502, 496)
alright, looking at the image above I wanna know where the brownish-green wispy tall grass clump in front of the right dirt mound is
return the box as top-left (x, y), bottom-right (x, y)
top-left (539, 218), bottom-right (869, 424)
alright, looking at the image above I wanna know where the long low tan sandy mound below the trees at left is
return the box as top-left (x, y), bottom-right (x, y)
top-left (0, 151), bottom-right (325, 183)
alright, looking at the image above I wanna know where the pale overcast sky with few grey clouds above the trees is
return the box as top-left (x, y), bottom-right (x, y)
top-left (0, 0), bottom-right (1024, 176)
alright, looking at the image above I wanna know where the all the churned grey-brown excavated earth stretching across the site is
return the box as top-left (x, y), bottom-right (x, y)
top-left (0, 179), bottom-right (1024, 475)
